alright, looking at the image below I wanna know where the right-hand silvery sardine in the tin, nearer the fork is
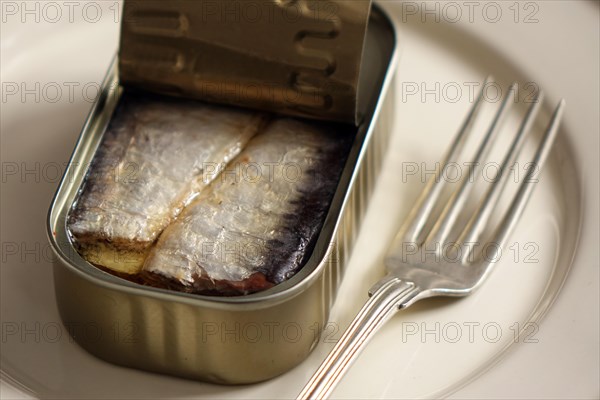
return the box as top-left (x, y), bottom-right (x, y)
top-left (142, 118), bottom-right (350, 295)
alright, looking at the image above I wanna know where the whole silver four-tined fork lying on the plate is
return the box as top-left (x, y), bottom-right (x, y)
top-left (298, 78), bottom-right (565, 400)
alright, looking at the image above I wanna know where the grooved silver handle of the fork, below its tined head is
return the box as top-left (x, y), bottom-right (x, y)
top-left (297, 275), bottom-right (420, 400)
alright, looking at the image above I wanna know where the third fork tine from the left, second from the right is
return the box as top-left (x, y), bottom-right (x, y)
top-left (457, 92), bottom-right (544, 263)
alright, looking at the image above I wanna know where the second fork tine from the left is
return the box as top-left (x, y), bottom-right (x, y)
top-left (426, 83), bottom-right (517, 244)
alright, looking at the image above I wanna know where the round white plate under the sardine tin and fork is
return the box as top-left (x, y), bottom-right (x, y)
top-left (0, 1), bottom-right (599, 398)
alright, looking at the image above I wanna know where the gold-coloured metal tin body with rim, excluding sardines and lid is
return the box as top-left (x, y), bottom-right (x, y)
top-left (47, 6), bottom-right (397, 384)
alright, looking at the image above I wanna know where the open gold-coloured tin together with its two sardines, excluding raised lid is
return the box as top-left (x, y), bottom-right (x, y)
top-left (48, 2), bottom-right (397, 384)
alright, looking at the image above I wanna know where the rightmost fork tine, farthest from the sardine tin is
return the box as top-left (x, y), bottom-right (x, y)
top-left (494, 99), bottom-right (566, 258)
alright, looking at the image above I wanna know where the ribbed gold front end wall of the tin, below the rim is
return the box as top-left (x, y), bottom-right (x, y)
top-left (55, 266), bottom-right (329, 384)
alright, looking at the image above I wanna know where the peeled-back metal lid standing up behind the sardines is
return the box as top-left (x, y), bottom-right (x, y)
top-left (119, 0), bottom-right (371, 123)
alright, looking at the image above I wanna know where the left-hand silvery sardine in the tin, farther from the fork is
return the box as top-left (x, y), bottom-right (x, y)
top-left (68, 92), bottom-right (265, 274)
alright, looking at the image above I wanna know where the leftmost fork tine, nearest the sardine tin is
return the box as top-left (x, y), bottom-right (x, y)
top-left (397, 76), bottom-right (492, 244)
